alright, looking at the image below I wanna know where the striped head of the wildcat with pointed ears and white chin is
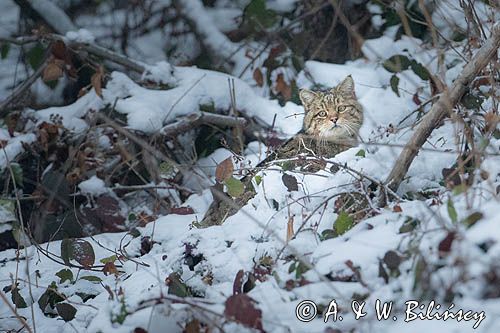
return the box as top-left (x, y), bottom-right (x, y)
top-left (300, 75), bottom-right (363, 141)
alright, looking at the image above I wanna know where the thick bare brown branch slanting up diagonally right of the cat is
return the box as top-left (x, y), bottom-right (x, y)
top-left (385, 23), bottom-right (500, 191)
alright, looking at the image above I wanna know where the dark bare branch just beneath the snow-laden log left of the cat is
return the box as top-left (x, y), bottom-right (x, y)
top-left (160, 111), bottom-right (247, 136)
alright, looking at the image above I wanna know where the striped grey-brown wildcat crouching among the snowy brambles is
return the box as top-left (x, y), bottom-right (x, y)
top-left (200, 75), bottom-right (363, 227)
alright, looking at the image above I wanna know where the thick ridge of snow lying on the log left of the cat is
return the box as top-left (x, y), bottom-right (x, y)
top-left (103, 67), bottom-right (302, 135)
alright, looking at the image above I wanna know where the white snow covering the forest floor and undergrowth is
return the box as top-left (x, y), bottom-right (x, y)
top-left (0, 1), bottom-right (500, 333)
